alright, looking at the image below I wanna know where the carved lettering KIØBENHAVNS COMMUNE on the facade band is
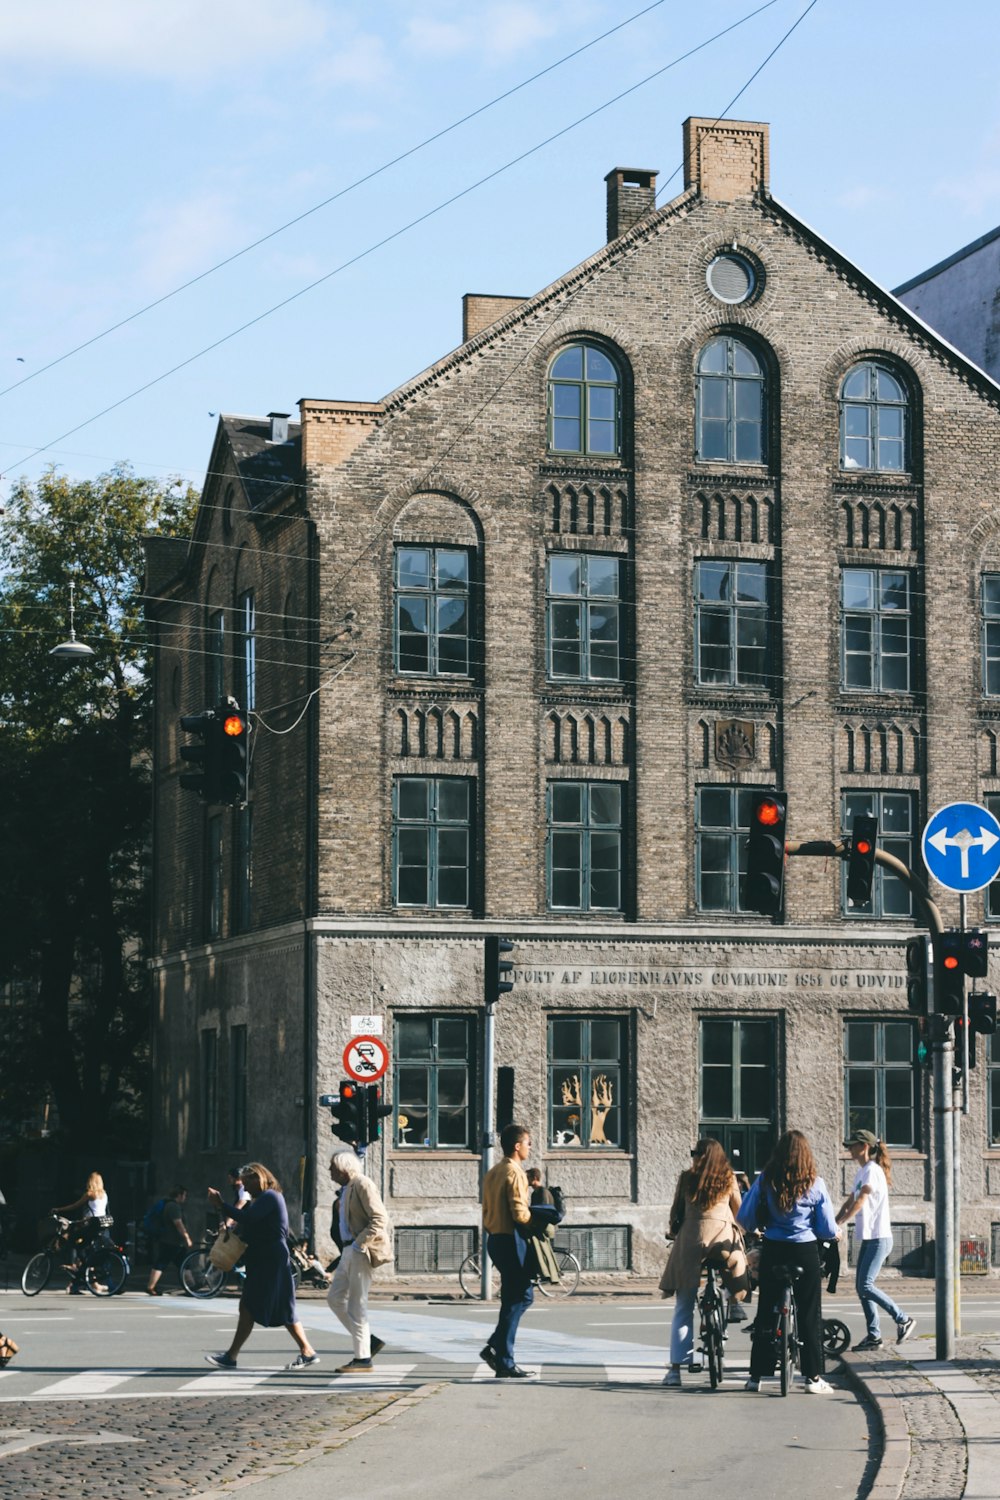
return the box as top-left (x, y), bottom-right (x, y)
top-left (514, 966), bottom-right (906, 992)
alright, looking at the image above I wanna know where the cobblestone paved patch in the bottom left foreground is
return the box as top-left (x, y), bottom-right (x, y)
top-left (0, 1391), bottom-right (418, 1500)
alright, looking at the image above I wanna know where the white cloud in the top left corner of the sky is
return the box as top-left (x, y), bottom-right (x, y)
top-left (0, 0), bottom-right (334, 83)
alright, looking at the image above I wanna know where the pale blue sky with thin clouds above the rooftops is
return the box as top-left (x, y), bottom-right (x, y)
top-left (0, 0), bottom-right (1000, 495)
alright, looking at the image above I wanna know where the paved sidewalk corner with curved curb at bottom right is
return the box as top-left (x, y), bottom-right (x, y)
top-left (843, 1335), bottom-right (1000, 1500)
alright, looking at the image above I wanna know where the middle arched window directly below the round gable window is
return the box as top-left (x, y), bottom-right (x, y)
top-left (697, 338), bottom-right (765, 464)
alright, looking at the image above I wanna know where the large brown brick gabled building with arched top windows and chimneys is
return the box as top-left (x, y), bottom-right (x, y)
top-left (150, 120), bottom-right (1000, 1272)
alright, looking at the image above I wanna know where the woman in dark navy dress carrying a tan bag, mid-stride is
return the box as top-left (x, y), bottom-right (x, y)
top-left (205, 1161), bottom-right (319, 1370)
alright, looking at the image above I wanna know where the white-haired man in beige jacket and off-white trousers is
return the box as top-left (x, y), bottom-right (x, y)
top-left (327, 1151), bottom-right (393, 1376)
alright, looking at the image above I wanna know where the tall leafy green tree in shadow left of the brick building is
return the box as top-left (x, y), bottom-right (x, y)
top-left (0, 465), bottom-right (196, 1149)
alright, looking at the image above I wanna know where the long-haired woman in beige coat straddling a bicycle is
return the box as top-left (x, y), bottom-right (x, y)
top-left (660, 1137), bottom-right (747, 1389)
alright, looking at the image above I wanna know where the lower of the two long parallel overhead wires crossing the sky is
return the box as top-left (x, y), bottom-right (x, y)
top-left (5, 0), bottom-right (791, 464)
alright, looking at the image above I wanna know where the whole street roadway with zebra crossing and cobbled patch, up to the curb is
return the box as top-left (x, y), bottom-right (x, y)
top-left (0, 1292), bottom-right (923, 1500)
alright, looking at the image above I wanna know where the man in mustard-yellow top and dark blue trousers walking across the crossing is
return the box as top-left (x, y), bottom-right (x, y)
top-left (480, 1125), bottom-right (535, 1380)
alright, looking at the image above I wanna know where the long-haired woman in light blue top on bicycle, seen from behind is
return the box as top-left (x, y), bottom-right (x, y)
top-left (738, 1130), bottom-right (840, 1395)
